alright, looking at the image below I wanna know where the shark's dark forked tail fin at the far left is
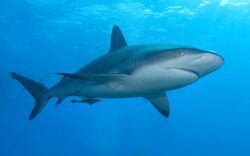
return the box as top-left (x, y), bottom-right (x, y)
top-left (10, 72), bottom-right (50, 120)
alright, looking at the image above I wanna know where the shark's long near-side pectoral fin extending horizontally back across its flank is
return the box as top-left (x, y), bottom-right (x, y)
top-left (56, 73), bottom-right (128, 82)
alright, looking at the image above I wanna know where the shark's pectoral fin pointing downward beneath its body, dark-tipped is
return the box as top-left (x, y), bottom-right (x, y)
top-left (144, 93), bottom-right (170, 117)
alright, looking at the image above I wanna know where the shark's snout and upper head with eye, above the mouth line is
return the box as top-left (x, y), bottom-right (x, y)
top-left (161, 48), bottom-right (224, 78)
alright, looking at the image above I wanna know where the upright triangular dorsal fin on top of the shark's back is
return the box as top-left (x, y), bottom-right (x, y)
top-left (109, 25), bottom-right (128, 52)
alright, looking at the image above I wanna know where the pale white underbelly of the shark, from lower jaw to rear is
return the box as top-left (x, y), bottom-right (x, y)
top-left (79, 66), bottom-right (198, 98)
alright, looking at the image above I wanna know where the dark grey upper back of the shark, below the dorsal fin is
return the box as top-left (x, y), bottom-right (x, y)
top-left (76, 44), bottom-right (184, 74)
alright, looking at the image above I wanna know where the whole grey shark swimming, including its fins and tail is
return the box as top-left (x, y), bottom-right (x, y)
top-left (11, 25), bottom-right (224, 120)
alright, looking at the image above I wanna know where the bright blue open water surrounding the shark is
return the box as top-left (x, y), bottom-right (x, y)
top-left (0, 0), bottom-right (250, 156)
